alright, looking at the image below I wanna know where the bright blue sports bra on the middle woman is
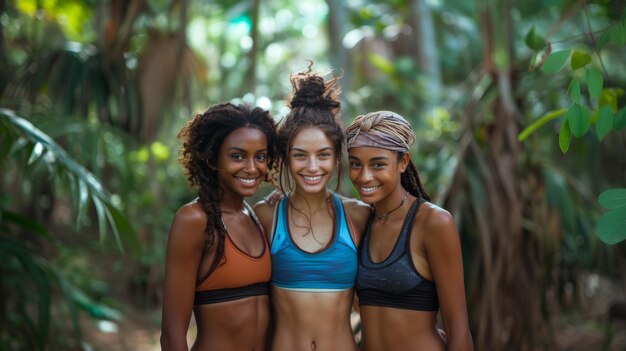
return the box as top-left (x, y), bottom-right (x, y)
top-left (270, 194), bottom-right (357, 292)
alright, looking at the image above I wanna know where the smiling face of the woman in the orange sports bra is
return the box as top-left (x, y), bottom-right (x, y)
top-left (217, 127), bottom-right (267, 197)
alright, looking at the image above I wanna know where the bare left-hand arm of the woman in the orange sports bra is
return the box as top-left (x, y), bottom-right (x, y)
top-left (161, 204), bottom-right (206, 351)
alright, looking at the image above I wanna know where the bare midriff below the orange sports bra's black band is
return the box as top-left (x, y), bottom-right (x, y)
top-left (191, 295), bottom-right (270, 351)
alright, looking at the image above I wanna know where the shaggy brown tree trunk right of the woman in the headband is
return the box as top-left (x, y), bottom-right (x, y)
top-left (469, 0), bottom-right (541, 350)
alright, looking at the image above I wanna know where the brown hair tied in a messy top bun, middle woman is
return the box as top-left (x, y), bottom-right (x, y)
top-left (276, 61), bottom-right (344, 192)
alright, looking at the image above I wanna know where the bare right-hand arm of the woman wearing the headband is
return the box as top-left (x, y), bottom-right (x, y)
top-left (423, 206), bottom-right (474, 351)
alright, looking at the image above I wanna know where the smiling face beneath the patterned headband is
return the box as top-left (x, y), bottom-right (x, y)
top-left (348, 147), bottom-right (409, 204)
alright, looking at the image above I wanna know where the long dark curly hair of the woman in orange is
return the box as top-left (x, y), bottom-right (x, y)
top-left (178, 103), bottom-right (276, 272)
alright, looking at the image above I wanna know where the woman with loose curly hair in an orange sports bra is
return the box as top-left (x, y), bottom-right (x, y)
top-left (161, 103), bottom-right (276, 351)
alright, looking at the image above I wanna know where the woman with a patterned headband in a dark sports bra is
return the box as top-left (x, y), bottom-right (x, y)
top-left (346, 111), bottom-right (473, 351)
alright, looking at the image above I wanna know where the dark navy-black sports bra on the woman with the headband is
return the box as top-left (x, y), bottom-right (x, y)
top-left (356, 199), bottom-right (439, 311)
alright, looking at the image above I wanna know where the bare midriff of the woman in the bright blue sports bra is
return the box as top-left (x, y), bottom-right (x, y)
top-left (271, 287), bottom-right (356, 351)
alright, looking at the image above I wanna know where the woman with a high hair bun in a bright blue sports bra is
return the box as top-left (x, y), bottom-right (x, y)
top-left (254, 66), bottom-right (371, 351)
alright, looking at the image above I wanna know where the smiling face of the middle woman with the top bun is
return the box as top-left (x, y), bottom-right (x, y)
top-left (289, 128), bottom-right (337, 193)
